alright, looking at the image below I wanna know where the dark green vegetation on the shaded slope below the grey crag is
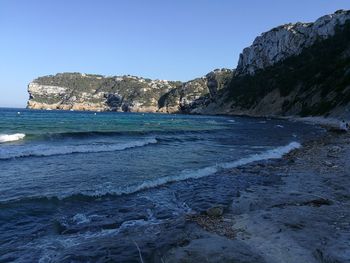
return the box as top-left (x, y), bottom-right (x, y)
top-left (226, 22), bottom-right (350, 115)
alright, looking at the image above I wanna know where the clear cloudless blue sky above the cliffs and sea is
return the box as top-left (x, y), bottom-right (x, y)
top-left (0, 0), bottom-right (350, 107)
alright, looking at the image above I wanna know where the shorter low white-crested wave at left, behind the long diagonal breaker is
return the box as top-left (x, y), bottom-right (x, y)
top-left (0, 138), bottom-right (158, 160)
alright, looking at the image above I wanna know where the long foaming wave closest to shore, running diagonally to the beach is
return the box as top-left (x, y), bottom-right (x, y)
top-left (0, 142), bottom-right (301, 205)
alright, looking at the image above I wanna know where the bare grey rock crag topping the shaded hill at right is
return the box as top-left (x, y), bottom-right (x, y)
top-left (236, 10), bottom-right (350, 75)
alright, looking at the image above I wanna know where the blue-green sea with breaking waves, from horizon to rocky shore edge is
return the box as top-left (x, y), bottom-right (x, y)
top-left (0, 109), bottom-right (322, 262)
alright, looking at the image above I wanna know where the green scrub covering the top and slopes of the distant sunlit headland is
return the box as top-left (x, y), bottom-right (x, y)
top-left (34, 73), bottom-right (178, 110)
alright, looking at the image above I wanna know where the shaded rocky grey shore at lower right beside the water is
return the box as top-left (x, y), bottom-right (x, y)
top-left (163, 129), bottom-right (350, 263)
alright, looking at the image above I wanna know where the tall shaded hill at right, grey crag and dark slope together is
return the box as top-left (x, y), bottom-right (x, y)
top-left (202, 10), bottom-right (350, 118)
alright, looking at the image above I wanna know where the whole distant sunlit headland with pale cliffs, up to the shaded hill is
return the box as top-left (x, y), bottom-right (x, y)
top-left (28, 69), bottom-right (232, 113)
